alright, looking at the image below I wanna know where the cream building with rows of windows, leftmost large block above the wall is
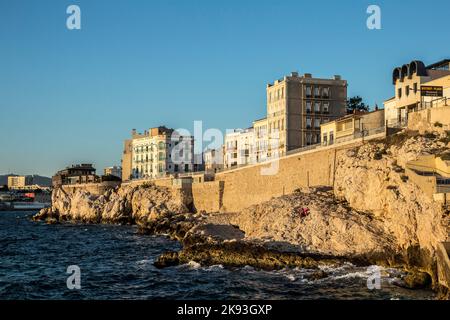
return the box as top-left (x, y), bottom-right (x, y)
top-left (122, 126), bottom-right (196, 180)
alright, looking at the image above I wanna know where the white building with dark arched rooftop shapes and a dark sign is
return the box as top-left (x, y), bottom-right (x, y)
top-left (384, 59), bottom-right (450, 126)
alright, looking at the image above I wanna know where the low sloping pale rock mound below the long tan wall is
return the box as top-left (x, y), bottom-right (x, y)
top-left (221, 189), bottom-right (392, 257)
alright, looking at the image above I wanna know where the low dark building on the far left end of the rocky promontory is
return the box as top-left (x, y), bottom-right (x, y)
top-left (52, 164), bottom-right (100, 187)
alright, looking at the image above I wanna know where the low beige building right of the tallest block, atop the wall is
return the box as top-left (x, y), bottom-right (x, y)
top-left (320, 110), bottom-right (385, 146)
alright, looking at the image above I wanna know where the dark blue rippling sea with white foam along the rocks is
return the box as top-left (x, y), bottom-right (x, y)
top-left (0, 212), bottom-right (433, 299)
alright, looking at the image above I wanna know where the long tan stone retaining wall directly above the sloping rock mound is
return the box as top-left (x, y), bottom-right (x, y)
top-left (215, 141), bottom-right (361, 212)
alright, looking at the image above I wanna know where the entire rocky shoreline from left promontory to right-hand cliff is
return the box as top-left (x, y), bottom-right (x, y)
top-left (33, 133), bottom-right (448, 298)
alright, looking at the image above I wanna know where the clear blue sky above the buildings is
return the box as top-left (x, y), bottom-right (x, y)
top-left (0, 0), bottom-right (450, 175)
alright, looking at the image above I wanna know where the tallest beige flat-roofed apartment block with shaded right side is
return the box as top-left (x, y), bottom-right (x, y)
top-left (266, 72), bottom-right (347, 156)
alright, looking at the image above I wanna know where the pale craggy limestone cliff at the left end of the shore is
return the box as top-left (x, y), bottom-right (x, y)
top-left (36, 185), bottom-right (189, 223)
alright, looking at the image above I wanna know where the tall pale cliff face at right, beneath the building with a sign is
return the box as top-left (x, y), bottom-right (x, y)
top-left (334, 132), bottom-right (446, 258)
